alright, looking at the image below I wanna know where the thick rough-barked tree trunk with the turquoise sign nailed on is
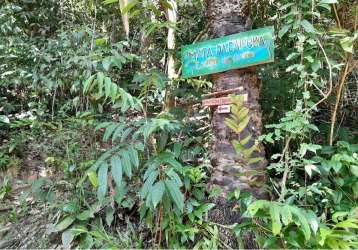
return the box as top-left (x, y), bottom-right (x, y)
top-left (207, 0), bottom-right (266, 227)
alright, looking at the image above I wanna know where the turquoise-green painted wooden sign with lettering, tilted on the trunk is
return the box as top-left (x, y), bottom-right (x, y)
top-left (182, 27), bottom-right (274, 78)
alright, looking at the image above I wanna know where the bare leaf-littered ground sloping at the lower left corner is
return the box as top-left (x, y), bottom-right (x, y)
top-left (0, 146), bottom-right (57, 249)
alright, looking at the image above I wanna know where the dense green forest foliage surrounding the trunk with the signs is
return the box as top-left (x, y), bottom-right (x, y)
top-left (0, 0), bottom-right (358, 249)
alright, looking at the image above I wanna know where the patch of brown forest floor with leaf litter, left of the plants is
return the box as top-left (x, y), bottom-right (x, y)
top-left (0, 133), bottom-right (77, 249)
